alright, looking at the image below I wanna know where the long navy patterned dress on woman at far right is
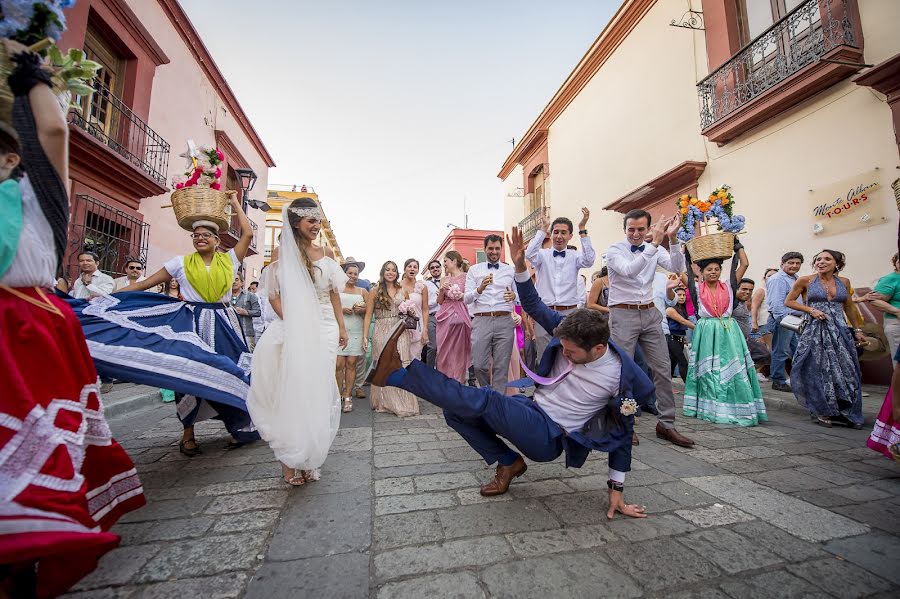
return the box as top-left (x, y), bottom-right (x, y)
top-left (791, 276), bottom-right (863, 424)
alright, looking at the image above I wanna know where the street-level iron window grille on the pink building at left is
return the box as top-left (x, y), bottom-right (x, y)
top-left (64, 194), bottom-right (150, 279)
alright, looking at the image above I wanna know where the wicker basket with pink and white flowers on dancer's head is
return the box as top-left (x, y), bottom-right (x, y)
top-left (171, 140), bottom-right (234, 231)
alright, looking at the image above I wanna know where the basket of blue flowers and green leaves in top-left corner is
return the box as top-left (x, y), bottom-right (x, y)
top-left (0, 0), bottom-right (101, 122)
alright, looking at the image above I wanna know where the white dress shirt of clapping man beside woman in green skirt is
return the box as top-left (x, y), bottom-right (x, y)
top-left (606, 240), bottom-right (684, 306)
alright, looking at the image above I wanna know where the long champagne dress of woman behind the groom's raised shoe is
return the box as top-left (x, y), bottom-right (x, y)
top-left (369, 290), bottom-right (418, 416)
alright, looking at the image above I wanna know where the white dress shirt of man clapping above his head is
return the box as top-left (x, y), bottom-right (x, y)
top-left (525, 229), bottom-right (595, 306)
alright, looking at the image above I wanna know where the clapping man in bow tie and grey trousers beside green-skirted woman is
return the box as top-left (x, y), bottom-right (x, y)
top-left (606, 210), bottom-right (694, 447)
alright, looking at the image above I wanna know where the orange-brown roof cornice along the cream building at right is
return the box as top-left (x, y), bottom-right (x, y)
top-left (497, 0), bottom-right (656, 179)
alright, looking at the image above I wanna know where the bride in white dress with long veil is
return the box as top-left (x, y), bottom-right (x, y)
top-left (247, 198), bottom-right (347, 486)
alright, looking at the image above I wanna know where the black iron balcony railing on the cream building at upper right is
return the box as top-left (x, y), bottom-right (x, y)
top-left (697, 0), bottom-right (857, 130)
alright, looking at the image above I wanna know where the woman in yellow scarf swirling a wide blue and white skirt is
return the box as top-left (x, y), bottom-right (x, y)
top-left (81, 192), bottom-right (259, 457)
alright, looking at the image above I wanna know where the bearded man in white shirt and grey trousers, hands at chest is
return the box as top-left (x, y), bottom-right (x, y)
top-left (463, 235), bottom-right (516, 393)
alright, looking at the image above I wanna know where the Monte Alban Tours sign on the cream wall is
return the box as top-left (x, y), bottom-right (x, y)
top-left (809, 169), bottom-right (887, 236)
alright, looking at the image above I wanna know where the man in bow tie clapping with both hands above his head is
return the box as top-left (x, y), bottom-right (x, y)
top-left (525, 208), bottom-right (595, 359)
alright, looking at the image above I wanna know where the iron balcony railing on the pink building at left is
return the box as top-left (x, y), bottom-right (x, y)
top-left (69, 79), bottom-right (170, 185)
